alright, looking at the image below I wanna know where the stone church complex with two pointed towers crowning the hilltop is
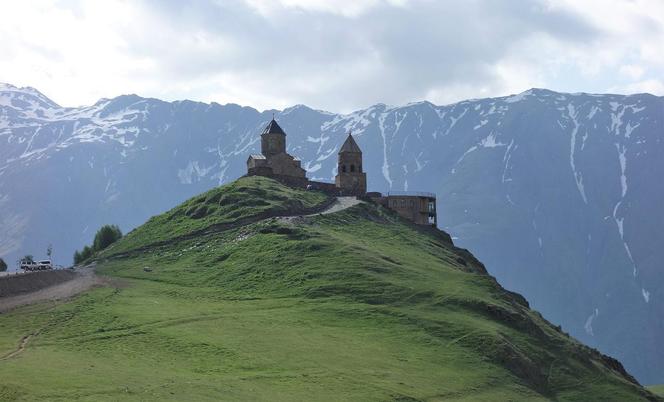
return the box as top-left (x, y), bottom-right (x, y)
top-left (247, 118), bottom-right (437, 226)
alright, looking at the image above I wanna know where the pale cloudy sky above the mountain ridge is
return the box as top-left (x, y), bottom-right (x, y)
top-left (0, 0), bottom-right (664, 112)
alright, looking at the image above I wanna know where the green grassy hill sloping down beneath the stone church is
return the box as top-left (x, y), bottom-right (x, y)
top-left (0, 177), bottom-right (657, 401)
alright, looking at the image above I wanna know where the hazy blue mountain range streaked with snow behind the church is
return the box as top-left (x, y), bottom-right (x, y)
top-left (0, 84), bottom-right (664, 383)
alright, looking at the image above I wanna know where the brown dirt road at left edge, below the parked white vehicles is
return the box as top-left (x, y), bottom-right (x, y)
top-left (0, 267), bottom-right (105, 314)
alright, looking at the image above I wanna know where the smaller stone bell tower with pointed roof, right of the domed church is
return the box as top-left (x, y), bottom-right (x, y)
top-left (334, 134), bottom-right (367, 196)
